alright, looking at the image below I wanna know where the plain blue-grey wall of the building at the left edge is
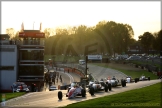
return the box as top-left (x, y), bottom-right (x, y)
top-left (0, 45), bottom-right (18, 91)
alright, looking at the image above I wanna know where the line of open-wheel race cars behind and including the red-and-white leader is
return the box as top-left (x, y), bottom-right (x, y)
top-left (58, 75), bottom-right (150, 100)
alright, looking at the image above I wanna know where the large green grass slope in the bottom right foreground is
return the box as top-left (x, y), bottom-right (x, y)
top-left (64, 83), bottom-right (161, 108)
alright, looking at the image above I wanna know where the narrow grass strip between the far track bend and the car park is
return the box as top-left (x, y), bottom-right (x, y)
top-left (96, 63), bottom-right (158, 79)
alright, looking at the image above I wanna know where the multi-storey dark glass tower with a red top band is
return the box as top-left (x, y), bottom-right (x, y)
top-left (17, 24), bottom-right (45, 89)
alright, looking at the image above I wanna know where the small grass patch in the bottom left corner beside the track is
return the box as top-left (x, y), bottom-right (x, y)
top-left (0, 92), bottom-right (26, 102)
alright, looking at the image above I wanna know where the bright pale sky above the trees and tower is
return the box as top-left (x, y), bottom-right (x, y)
top-left (1, 1), bottom-right (161, 40)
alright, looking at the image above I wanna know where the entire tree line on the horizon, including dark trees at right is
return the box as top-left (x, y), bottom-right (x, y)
top-left (6, 21), bottom-right (162, 55)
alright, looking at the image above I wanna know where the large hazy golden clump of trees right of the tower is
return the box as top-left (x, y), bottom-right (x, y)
top-left (45, 21), bottom-right (134, 55)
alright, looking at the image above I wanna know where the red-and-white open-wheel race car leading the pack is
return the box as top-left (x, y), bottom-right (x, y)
top-left (66, 82), bottom-right (86, 99)
